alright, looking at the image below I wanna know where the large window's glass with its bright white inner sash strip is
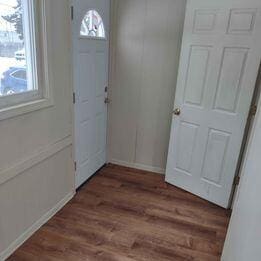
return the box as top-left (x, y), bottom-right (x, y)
top-left (0, 0), bottom-right (35, 97)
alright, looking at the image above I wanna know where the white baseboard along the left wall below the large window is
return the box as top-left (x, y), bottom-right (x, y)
top-left (0, 192), bottom-right (75, 261)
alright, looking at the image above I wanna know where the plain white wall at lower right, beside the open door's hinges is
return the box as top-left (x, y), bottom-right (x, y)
top-left (222, 82), bottom-right (261, 261)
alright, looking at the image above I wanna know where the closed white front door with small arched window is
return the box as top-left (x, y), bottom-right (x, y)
top-left (72, 0), bottom-right (110, 187)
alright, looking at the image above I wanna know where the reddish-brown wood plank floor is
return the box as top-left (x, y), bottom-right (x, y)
top-left (8, 165), bottom-right (229, 261)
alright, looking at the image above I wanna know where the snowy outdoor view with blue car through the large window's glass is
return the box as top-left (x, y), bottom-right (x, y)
top-left (0, 0), bottom-right (29, 96)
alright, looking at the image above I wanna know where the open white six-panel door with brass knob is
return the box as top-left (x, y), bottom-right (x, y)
top-left (166, 0), bottom-right (261, 207)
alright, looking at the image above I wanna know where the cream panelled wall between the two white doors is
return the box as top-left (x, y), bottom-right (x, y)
top-left (108, 0), bottom-right (186, 172)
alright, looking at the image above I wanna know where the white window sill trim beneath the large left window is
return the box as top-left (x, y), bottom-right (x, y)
top-left (0, 98), bottom-right (54, 121)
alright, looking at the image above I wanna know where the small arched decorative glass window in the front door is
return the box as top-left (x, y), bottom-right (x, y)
top-left (80, 10), bottom-right (105, 38)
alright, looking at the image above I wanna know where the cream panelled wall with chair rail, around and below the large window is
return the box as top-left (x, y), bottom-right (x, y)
top-left (0, 0), bottom-right (74, 260)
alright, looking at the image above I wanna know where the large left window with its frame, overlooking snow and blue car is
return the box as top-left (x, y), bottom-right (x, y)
top-left (0, 0), bottom-right (51, 114)
